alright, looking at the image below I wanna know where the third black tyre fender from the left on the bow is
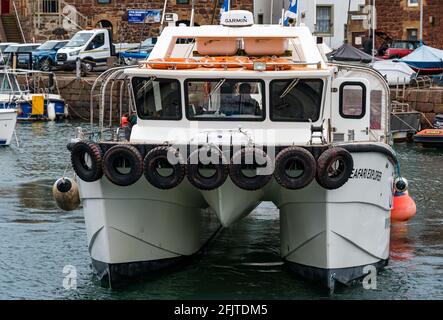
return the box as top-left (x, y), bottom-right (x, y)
top-left (143, 146), bottom-right (186, 190)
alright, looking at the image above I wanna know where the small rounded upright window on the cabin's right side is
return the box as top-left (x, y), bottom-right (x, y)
top-left (340, 82), bottom-right (366, 119)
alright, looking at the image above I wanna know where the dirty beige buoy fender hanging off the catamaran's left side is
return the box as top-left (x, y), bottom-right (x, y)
top-left (52, 178), bottom-right (80, 211)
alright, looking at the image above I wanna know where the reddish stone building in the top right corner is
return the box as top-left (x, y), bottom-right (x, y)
top-left (369, 0), bottom-right (443, 49)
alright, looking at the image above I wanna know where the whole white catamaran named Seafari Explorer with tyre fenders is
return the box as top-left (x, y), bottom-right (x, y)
top-left (59, 11), bottom-right (416, 289)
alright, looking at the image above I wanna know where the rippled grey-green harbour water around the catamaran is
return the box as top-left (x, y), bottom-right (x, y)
top-left (0, 122), bottom-right (443, 300)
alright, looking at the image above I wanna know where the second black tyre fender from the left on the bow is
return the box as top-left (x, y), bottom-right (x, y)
top-left (103, 144), bottom-right (143, 187)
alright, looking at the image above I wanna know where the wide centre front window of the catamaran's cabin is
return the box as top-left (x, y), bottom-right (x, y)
top-left (185, 79), bottom-right (265, 121)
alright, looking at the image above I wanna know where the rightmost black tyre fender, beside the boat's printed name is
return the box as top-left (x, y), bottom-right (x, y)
top-left (316, 147), bottom-right (354, 190)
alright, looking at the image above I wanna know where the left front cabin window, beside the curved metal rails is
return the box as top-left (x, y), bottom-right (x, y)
top-left (132, 78), bottom-right (182, 120)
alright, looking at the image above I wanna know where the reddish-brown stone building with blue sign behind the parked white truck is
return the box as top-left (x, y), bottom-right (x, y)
top-left (0, 0), bottom-right (253, 42)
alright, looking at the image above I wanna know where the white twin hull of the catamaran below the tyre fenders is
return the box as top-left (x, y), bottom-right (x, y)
top-left (80, 152), bottom-right (394, 287)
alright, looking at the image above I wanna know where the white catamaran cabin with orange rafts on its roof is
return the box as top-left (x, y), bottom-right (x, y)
top-left (125, 10), bottom-right (389, 145)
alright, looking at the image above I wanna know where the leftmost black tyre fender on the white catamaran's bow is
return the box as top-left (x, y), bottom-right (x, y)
top-left (71, 141), bottom-right (103, 182)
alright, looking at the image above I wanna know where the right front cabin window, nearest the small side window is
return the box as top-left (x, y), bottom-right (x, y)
top-left (270, 79), bottom-right (323, 122)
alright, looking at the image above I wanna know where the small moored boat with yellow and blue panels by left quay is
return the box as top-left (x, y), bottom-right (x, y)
top-left (0, 68), bottom-right (68, 121)
